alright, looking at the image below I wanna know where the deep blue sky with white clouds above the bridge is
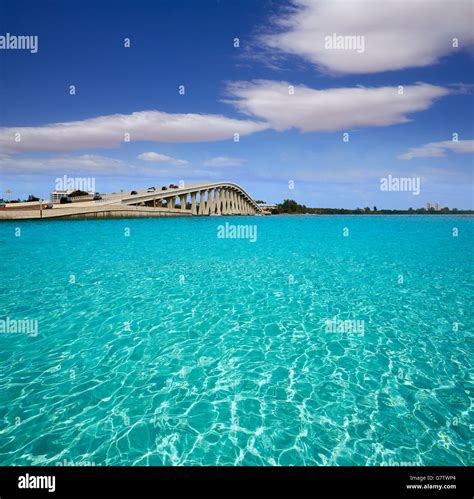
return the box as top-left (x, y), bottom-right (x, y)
top-left (0, 0), bottom-right (474, 209)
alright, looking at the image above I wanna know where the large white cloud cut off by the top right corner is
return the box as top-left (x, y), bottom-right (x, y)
top-left (260, 0), bottom-right (474, 74)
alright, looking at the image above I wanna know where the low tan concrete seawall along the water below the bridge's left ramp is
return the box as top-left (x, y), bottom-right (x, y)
top-left (0, 205), bottom-right (192, 220)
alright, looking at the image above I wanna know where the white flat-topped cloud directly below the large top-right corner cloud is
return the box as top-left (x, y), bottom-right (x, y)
top-left (226, 80), bottom-right (450, 132)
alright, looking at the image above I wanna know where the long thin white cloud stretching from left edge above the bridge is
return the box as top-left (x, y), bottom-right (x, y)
top-left (0, 111), bottom-right (267, 153)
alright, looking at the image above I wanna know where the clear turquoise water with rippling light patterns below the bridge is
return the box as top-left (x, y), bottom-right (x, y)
top-left (0, 216), bottom-right (474, 466)
